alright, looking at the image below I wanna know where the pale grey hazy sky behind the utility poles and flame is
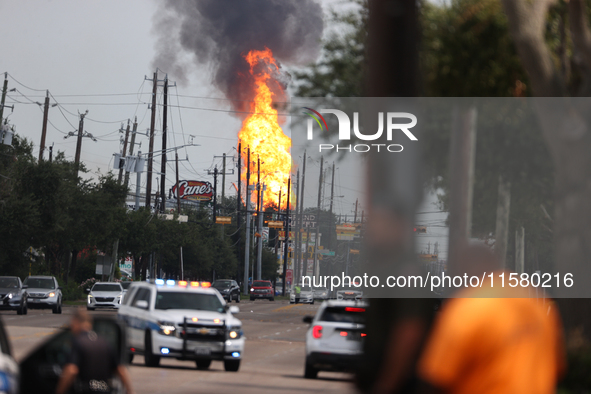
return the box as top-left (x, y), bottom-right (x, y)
top-left (0, 0), bottom-right (448, 258)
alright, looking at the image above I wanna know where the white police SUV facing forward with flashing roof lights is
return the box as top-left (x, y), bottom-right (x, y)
top-left (118, 279), bottom-right (245, 372)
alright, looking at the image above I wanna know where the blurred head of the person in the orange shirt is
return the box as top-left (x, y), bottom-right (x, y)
top-left (450, 245), bottom-right (502, 276)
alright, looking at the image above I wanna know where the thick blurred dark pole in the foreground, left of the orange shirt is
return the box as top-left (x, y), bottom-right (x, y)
top-left (356, 0), bottom-right (433, 393)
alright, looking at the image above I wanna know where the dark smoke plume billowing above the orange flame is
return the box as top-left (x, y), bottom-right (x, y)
top-left (154, 0), bottom-right (323, 110)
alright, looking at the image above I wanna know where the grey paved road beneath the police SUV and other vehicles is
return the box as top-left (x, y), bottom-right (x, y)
top-left (0, 300), bottom-right (354, 394)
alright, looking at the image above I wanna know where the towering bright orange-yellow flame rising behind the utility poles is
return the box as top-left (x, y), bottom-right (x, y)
top-left (238, 48), bottom-right (291, 208)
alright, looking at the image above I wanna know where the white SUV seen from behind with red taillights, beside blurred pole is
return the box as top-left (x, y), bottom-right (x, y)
top-left (304, 300), bottom-right (366, 379)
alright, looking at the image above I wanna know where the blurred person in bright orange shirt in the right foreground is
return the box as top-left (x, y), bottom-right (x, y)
top-left (417, 246), bottom-right (566, 394)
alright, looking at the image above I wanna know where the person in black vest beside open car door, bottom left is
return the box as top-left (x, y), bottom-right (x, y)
top-left (56, 308), bottom-right (134, 394)
